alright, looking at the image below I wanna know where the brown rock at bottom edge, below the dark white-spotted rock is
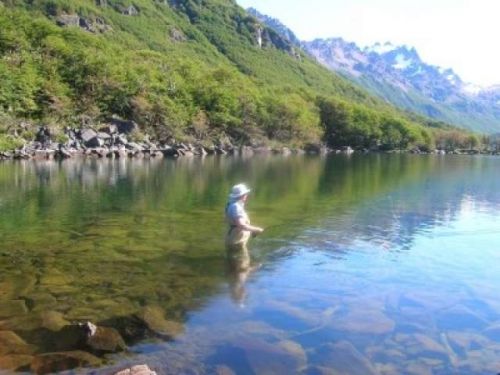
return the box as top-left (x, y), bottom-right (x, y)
top-left (31, 350), bottom-right (101, 374)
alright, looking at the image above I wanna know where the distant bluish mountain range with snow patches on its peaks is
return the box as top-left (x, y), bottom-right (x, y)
top-left (303, 38), bottom-right (500, 133)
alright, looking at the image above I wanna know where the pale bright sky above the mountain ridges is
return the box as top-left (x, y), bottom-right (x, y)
top-left (237, 0), bottom-right (500, 86)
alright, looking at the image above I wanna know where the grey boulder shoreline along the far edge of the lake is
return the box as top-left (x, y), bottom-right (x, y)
top-left (0, 118), bottom-right (494, 160)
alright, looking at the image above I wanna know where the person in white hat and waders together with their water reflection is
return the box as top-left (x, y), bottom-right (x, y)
top-left (226, 184), bottom-right (264, 306)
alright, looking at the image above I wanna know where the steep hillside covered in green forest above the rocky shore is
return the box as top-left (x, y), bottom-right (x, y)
top-left (0, 0), bottom-right (480, 150)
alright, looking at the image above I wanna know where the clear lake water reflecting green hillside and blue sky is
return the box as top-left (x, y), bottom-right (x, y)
top-left (0, 155), bottom-right (500, 374)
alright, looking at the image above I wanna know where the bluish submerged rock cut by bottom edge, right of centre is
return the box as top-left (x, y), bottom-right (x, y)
top-left (317, 341), bottom-right (377, 375)
